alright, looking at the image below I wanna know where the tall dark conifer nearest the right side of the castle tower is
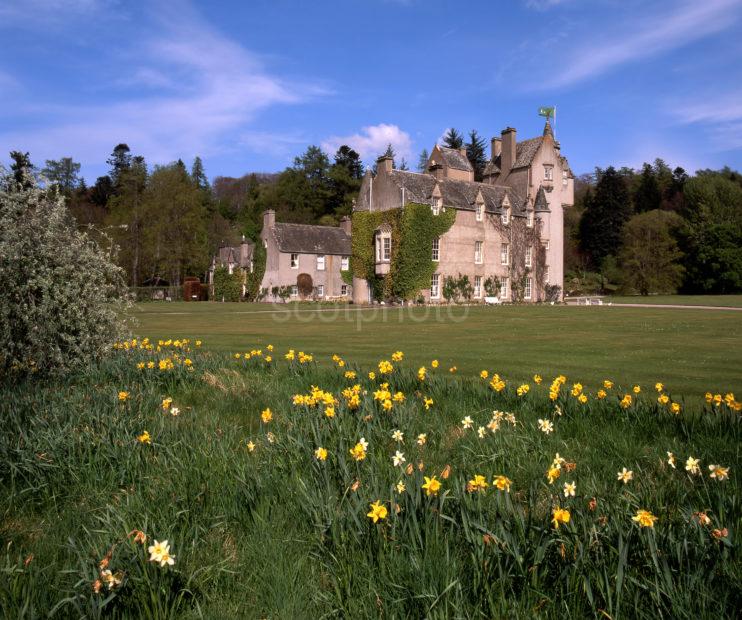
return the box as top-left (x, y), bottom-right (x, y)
top-left (580, 166), bottom-right (631, 267)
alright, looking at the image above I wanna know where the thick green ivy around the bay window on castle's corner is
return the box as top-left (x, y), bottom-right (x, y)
top-left (351, 203), bottom-right (456, 299)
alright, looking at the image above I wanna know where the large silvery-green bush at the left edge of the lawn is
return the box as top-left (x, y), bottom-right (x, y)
top-left (0, 180), bottom-right (126, 374)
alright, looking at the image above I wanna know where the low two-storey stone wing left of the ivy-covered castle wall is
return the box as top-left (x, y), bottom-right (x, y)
top-left (260, 211), bottom-right (351, 301)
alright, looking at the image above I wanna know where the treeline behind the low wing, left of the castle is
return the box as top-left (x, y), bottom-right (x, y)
top-left (5, 144), bottom-right (364, 286)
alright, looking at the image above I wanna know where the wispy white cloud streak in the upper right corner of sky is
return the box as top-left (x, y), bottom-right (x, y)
top-left (540, 0), bottom-right (740, 88)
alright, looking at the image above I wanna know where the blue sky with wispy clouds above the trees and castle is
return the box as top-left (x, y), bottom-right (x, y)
top-left (0, 0), bottom-right (742, 183)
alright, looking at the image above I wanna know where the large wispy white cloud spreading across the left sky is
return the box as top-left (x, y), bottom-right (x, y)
top-left (0, 0), bottom-right (329, 164)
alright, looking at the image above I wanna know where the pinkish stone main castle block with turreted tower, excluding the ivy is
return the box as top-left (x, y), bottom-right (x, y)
top-left (353, 121), bottom-right (574, 303)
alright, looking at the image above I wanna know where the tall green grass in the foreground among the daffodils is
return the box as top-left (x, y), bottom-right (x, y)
top-left (0, 342), bottom-right (742, 618)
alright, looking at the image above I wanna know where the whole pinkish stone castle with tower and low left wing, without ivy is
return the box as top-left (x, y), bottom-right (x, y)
top-left (212, 120), bottom-right (574, 304)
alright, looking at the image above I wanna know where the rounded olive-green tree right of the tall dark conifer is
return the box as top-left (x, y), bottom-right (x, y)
top-left (619, 209), bottom-right (683, 295)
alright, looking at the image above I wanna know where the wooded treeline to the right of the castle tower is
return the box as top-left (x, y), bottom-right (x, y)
top-left (564, 159), bottom-right (742, 295)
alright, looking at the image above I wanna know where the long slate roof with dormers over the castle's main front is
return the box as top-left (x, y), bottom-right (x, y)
top-left (391, 170), bottom-right (525, 215)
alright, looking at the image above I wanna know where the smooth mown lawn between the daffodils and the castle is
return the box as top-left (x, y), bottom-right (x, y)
top-left (134, 303), bottom-right (742, 404)
